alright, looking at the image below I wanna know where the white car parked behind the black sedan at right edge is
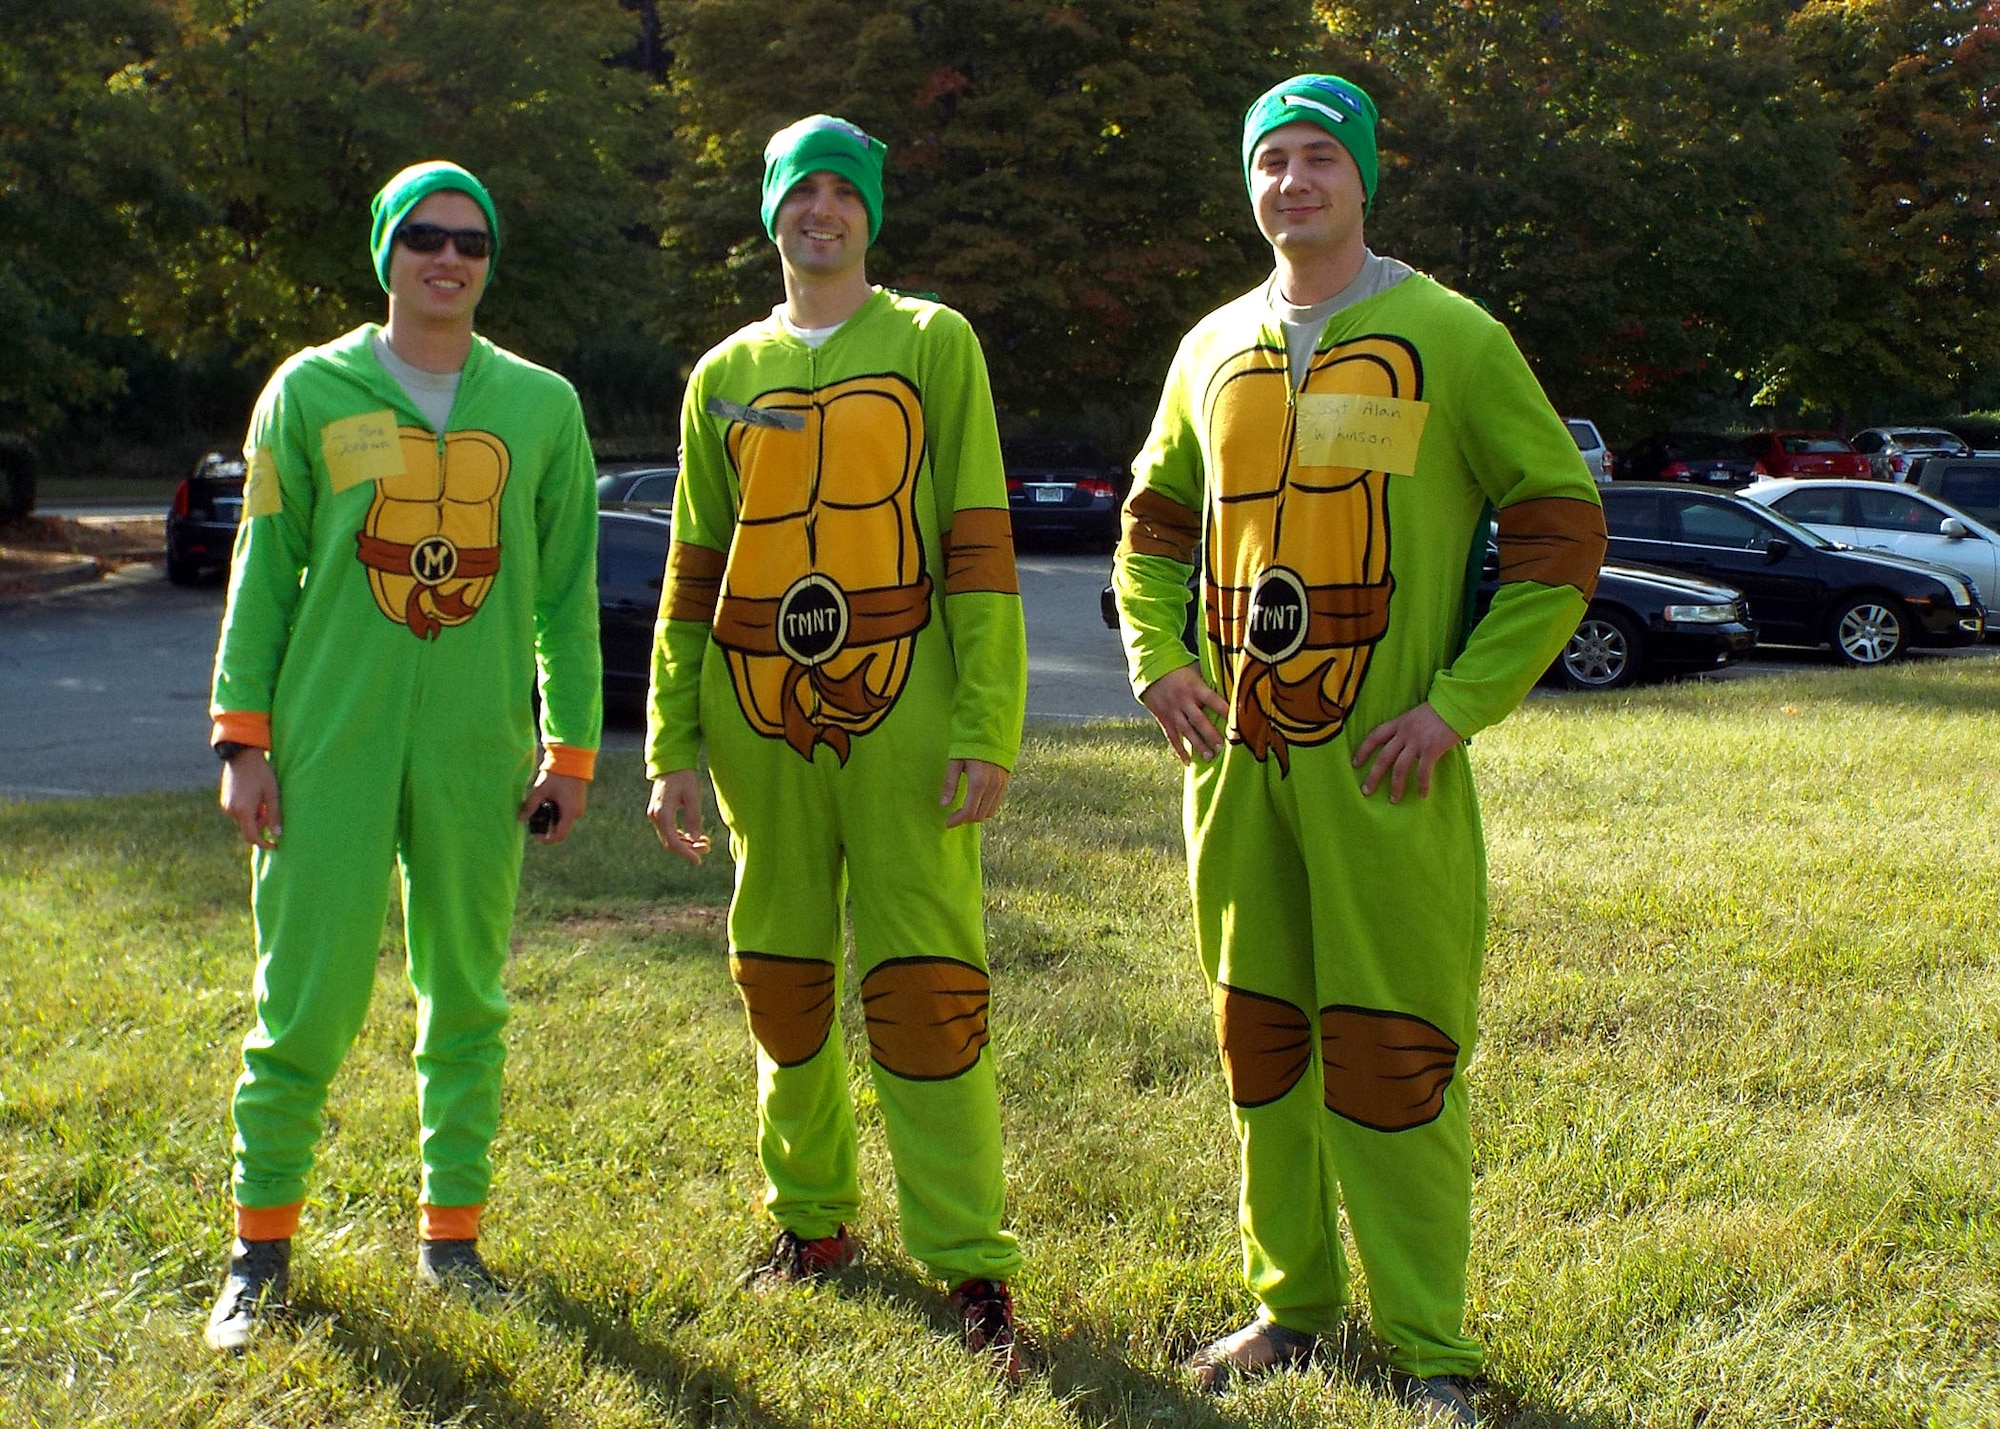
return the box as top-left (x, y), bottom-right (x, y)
top-left (1736, 480), bottom-right (2000, 608)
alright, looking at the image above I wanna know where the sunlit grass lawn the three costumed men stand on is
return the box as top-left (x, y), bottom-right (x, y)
top-left (0, 660), bottom-right (2000, 1429)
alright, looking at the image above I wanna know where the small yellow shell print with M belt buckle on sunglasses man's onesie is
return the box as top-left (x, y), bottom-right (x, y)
top-left (354, 426), bottom-right (512, 640)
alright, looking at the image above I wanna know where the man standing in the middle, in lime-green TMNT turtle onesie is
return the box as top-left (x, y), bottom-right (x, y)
top-left (648, 114), bottom-right (1028, 1379)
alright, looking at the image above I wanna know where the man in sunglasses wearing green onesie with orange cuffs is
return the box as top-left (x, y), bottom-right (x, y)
top-left (208, 160), bottom-right (602, 1351)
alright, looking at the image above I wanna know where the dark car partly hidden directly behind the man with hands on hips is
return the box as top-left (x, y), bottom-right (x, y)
top-left (1098, 546), bottom-right (1756, 690)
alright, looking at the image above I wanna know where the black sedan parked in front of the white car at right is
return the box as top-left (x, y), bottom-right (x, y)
top-left (1604, 484), bottom-right (1986, 664)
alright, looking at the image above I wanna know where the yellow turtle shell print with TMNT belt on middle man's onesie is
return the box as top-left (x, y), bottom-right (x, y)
top-left (720, 374), bottom-right (928, 763)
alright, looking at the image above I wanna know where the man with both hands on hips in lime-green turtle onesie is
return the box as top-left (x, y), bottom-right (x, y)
top-left (1114, 74), bottom-right (1604, 1423)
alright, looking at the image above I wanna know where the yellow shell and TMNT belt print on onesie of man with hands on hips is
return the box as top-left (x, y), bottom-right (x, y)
top-left (1192, 336), bottom-right (1424, 773)
